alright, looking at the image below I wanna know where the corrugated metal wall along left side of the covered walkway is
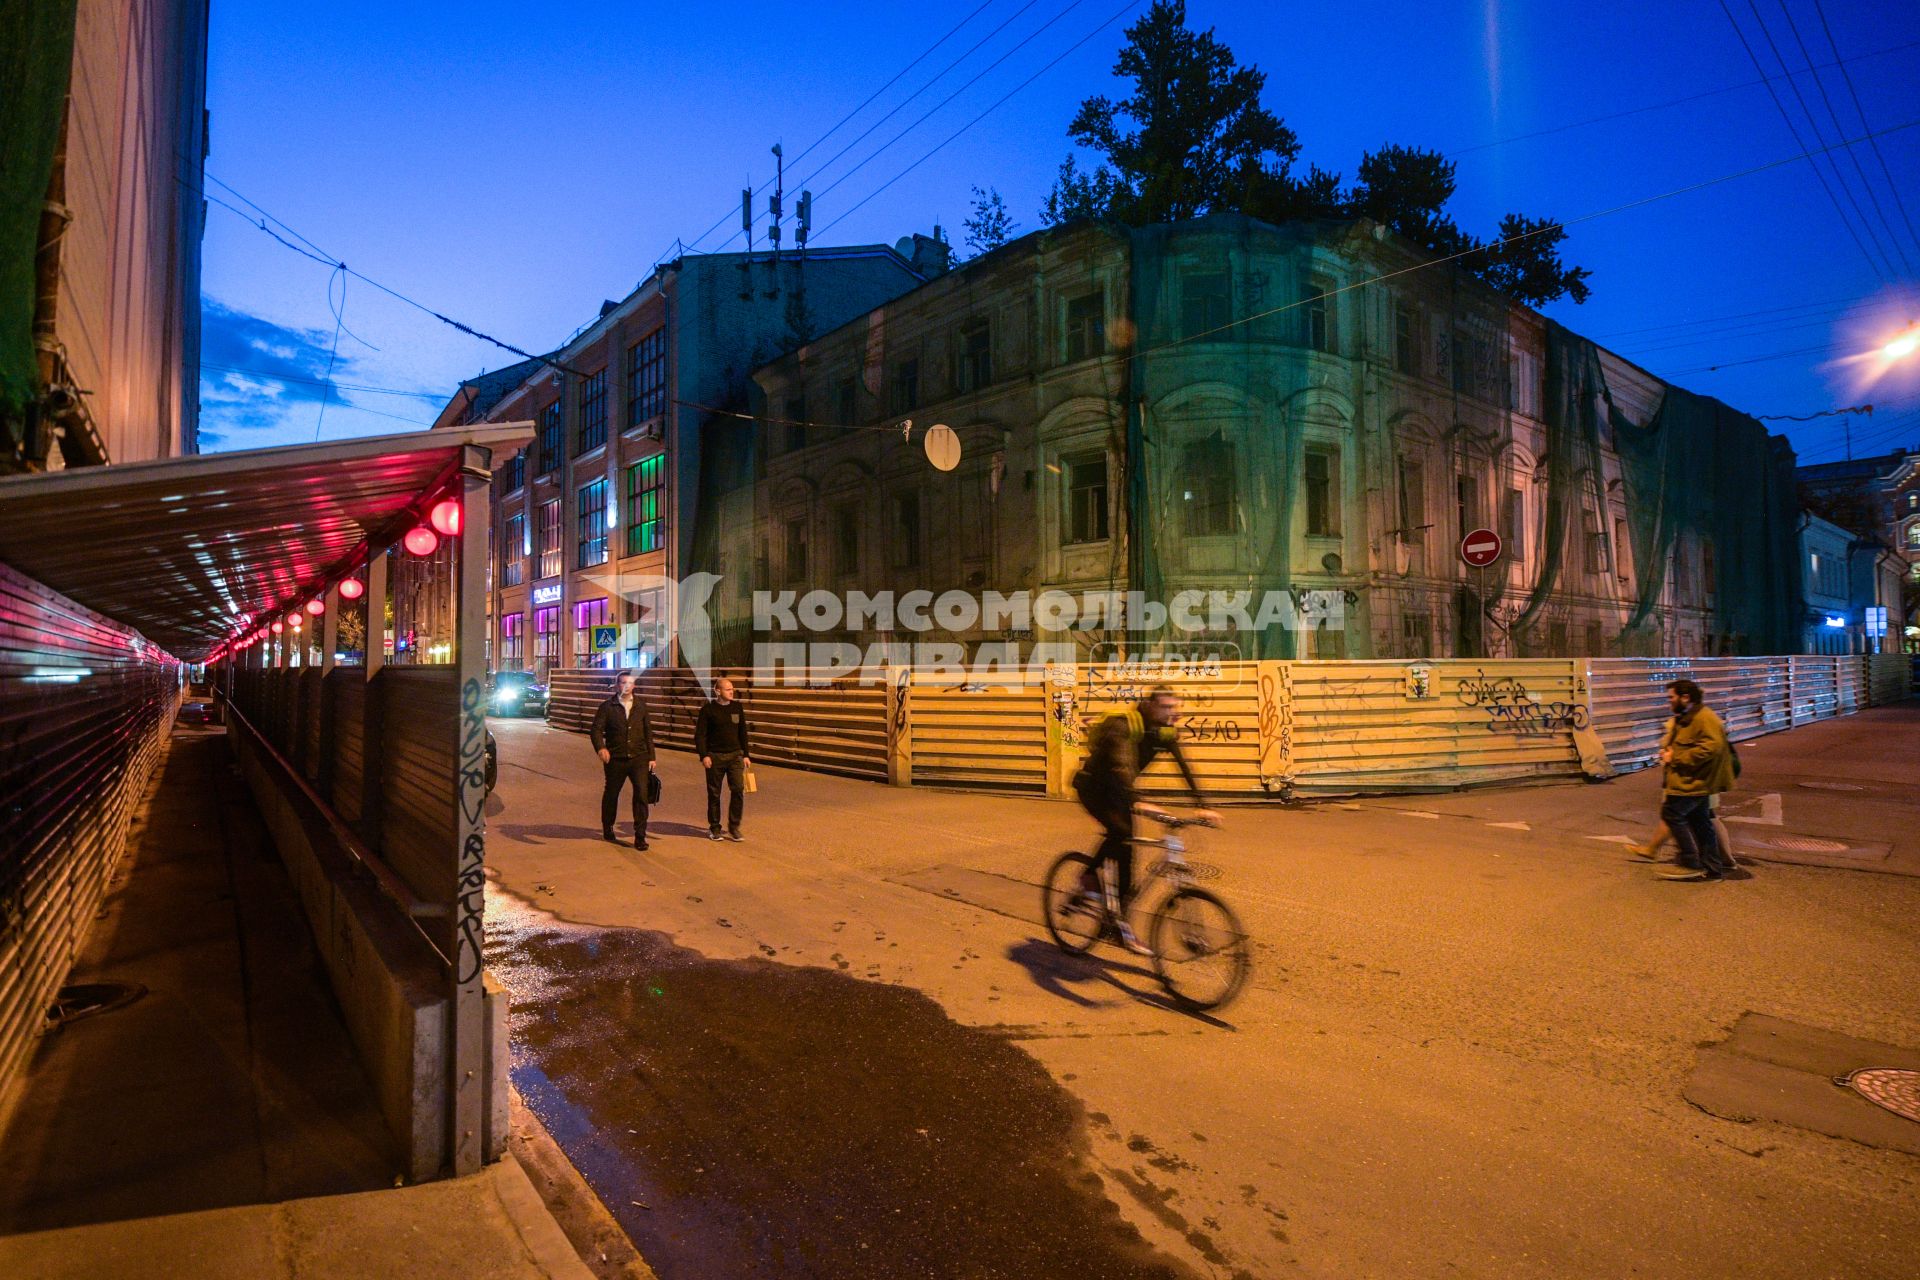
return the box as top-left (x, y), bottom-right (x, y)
top-left (0, 564), bottom-right (182, 1084)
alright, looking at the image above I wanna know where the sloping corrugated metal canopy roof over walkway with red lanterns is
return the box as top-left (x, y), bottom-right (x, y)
top-left (0, 422), bottom-right (532, 660)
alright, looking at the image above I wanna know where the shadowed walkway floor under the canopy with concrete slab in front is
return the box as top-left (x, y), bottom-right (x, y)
top-left (0, 723), bottom-right (589, 1280)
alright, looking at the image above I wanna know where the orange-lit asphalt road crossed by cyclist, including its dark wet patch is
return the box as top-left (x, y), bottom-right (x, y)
top-left (488, 706), bottom-right (1920, 1280)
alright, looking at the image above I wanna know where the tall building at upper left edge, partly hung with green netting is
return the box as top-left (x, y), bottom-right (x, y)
top-left (0, 0), bottom-right (207, 470)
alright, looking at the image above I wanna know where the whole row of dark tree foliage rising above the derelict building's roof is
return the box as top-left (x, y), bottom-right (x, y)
top-left (1041, 0), bottom-right (1590, 307)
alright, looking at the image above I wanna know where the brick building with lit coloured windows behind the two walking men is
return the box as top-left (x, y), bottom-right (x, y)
top-left (436, 236), bottom-right (947, 679)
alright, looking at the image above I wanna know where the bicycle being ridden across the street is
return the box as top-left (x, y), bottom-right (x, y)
top-left (1041, 814), bottom-right (1252, 1011)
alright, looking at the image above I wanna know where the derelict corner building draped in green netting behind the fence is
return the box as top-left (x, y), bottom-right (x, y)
top-left (716, 215), bottom-right (1801, 660)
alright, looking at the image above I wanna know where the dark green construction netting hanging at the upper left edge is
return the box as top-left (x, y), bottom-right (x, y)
top-left (0, 0), bottom-right (77, 430)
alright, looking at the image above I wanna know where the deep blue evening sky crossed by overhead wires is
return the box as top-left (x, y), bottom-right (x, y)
top-left (202, 0), bottom-right (1920, 461)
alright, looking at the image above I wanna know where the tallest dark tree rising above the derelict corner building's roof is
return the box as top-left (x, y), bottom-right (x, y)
top-left (1046, 0), bottom-right (1300, 226)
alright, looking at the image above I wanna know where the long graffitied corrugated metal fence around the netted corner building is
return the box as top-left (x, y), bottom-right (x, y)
top-left (549, 654), bottom-right (1912, 800)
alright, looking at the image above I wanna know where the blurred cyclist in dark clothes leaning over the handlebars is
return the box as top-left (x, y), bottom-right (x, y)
top-left (1073, 687), bottom-right (1219, 956)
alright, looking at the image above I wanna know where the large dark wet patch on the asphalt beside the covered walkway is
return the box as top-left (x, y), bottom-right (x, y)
top-left (488, 892), bottom-right (1192, 1280)
